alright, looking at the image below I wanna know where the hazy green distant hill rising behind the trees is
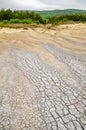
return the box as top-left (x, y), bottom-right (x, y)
top-left (37, 9), bottom-right (86, 18)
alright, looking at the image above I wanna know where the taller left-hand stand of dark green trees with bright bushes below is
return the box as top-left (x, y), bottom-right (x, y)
top-left (0, 9), bottom-right (46, 24)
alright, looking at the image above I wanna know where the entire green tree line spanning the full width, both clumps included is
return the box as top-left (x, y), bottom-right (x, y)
top-left (0, 9), bottom-right (86, 24)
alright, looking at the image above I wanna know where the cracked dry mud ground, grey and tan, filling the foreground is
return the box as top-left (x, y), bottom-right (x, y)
top-left (0, 24), bottom-right (86, 130)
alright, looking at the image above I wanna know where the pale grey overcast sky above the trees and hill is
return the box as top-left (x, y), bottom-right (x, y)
top-left (0, 0), bottom-right (86, 10)
